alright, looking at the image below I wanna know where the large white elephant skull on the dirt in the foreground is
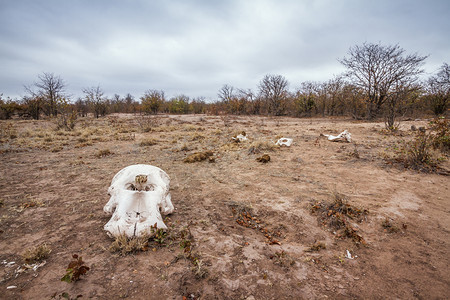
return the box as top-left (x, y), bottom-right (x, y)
top-left (103, 165), bottom-right (174, 237)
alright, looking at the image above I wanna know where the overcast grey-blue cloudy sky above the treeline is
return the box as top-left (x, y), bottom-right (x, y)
top-left (0, 0), bottom-right (450, 100)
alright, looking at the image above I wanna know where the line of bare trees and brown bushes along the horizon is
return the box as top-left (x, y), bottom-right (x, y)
top-left (0, 43), bottom-right (450, 120)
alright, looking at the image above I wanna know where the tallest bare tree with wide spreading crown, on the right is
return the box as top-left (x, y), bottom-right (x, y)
top-left (340, 43), bottom-right (427, 119)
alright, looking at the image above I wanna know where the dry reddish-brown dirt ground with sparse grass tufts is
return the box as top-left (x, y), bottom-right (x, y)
top-left (0, 115), bottom-right (450, 300)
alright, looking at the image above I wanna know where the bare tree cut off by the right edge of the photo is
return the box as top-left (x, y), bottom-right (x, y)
top-left (427, 63), bottom-right (450, 115)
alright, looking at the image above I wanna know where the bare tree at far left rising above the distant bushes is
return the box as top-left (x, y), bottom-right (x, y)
top-left (25, 72), bottom-right (66, 116)
